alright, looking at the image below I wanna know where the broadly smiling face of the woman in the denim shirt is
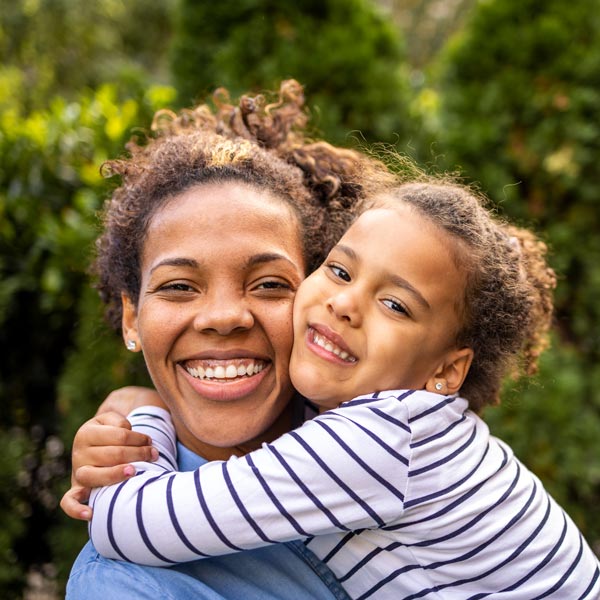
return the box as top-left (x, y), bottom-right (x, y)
top-left (123, 182), bottom-right (305, 458)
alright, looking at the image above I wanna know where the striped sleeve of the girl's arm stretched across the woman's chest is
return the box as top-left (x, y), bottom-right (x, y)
top-left (90, 397), bottom-right (410, 565)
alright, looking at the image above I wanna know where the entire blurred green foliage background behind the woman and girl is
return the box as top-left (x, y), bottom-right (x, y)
top-left (0, 0), bottom-right (600, 599)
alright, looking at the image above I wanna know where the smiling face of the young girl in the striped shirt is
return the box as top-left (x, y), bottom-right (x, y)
top-left (290, 207), bottom-right (471, 408)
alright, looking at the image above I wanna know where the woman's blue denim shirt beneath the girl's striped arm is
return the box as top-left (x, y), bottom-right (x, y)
top-left (66, 444), bottom-right (349, 600)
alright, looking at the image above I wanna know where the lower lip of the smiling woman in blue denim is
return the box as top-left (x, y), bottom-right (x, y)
top-left (177, 361), bottom-right (271, 402)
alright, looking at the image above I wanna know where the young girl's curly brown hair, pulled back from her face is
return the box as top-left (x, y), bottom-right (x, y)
top-left (374, 177), bottom-right (556, 412)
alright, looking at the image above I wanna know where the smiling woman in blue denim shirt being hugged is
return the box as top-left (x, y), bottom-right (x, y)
top-left (62, 82), bottom-right (391, 599)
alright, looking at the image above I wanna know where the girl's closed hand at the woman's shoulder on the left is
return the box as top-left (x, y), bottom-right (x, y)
top-left (60, 396), bottom-right (163, 520)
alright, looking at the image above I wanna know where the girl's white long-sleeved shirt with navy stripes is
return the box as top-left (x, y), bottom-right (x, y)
top-left (90, 391), bottom-right (600, 600)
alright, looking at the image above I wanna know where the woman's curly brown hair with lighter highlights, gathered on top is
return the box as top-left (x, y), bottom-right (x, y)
top-left (93, 80), bottom-right (392, 329)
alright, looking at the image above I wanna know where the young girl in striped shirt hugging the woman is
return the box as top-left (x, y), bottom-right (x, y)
top-left (85, 183), bottom-right (600, 600)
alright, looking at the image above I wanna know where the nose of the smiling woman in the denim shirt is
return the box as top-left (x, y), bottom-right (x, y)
top-left (194, 289), bottom-right (254, 335)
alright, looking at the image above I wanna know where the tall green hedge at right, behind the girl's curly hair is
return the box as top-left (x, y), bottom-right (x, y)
top-left (428, 0), bottom-right (600, 551)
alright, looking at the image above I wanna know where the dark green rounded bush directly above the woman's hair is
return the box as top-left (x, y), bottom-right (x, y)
top-left (171, 0), bottom-right (413, 143)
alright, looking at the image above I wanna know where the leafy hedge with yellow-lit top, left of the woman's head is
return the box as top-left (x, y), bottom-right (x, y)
top-left (0, 79), bottom-right (174, 598)
